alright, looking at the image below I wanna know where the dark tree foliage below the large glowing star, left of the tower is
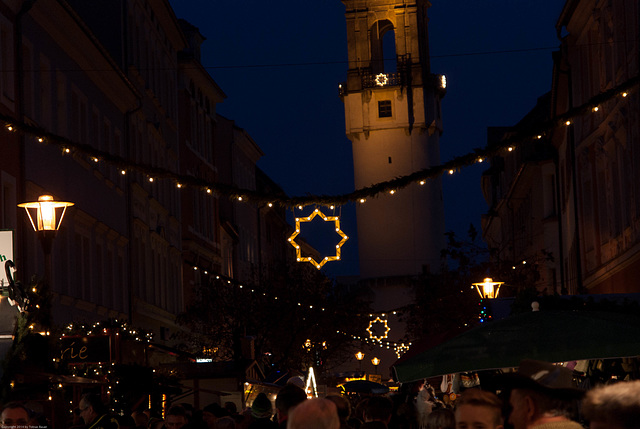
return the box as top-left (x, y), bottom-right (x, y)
top-left (177, 264), bottom-right (368, 369)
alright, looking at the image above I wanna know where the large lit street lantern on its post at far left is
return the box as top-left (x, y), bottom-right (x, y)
top-left (18, 195), bottom-right (73, 282)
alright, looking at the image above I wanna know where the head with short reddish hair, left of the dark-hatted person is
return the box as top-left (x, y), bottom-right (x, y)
top-left (452, 389), bottom-right (503, 429)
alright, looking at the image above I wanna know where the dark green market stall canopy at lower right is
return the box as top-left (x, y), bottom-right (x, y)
top-left (393, 311), bottom-right (640, 383)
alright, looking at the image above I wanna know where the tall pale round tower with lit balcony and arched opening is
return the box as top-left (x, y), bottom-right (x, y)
top-left (341, 0), bottom-right (445, 279)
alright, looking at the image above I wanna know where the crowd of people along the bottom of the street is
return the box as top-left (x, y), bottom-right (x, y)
top-left (0, 360), bottom-right (640, 429)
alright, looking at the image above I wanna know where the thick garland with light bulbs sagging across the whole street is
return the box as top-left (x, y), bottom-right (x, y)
top-left (0, 76), bottom-right (640, 208)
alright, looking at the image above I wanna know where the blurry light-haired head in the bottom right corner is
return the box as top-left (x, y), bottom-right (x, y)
top-left (582, 380), bottom-right (640, 429)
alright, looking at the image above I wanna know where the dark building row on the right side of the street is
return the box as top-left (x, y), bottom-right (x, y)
top-left (483, 0), bottom-right (640, 294)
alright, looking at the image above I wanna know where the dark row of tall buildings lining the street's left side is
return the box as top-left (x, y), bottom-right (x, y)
top-left (0, 0), bottom-right (290, 352)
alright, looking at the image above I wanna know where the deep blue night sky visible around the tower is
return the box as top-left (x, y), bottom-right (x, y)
top-left (170, 0), bottom-right (564, 276)
